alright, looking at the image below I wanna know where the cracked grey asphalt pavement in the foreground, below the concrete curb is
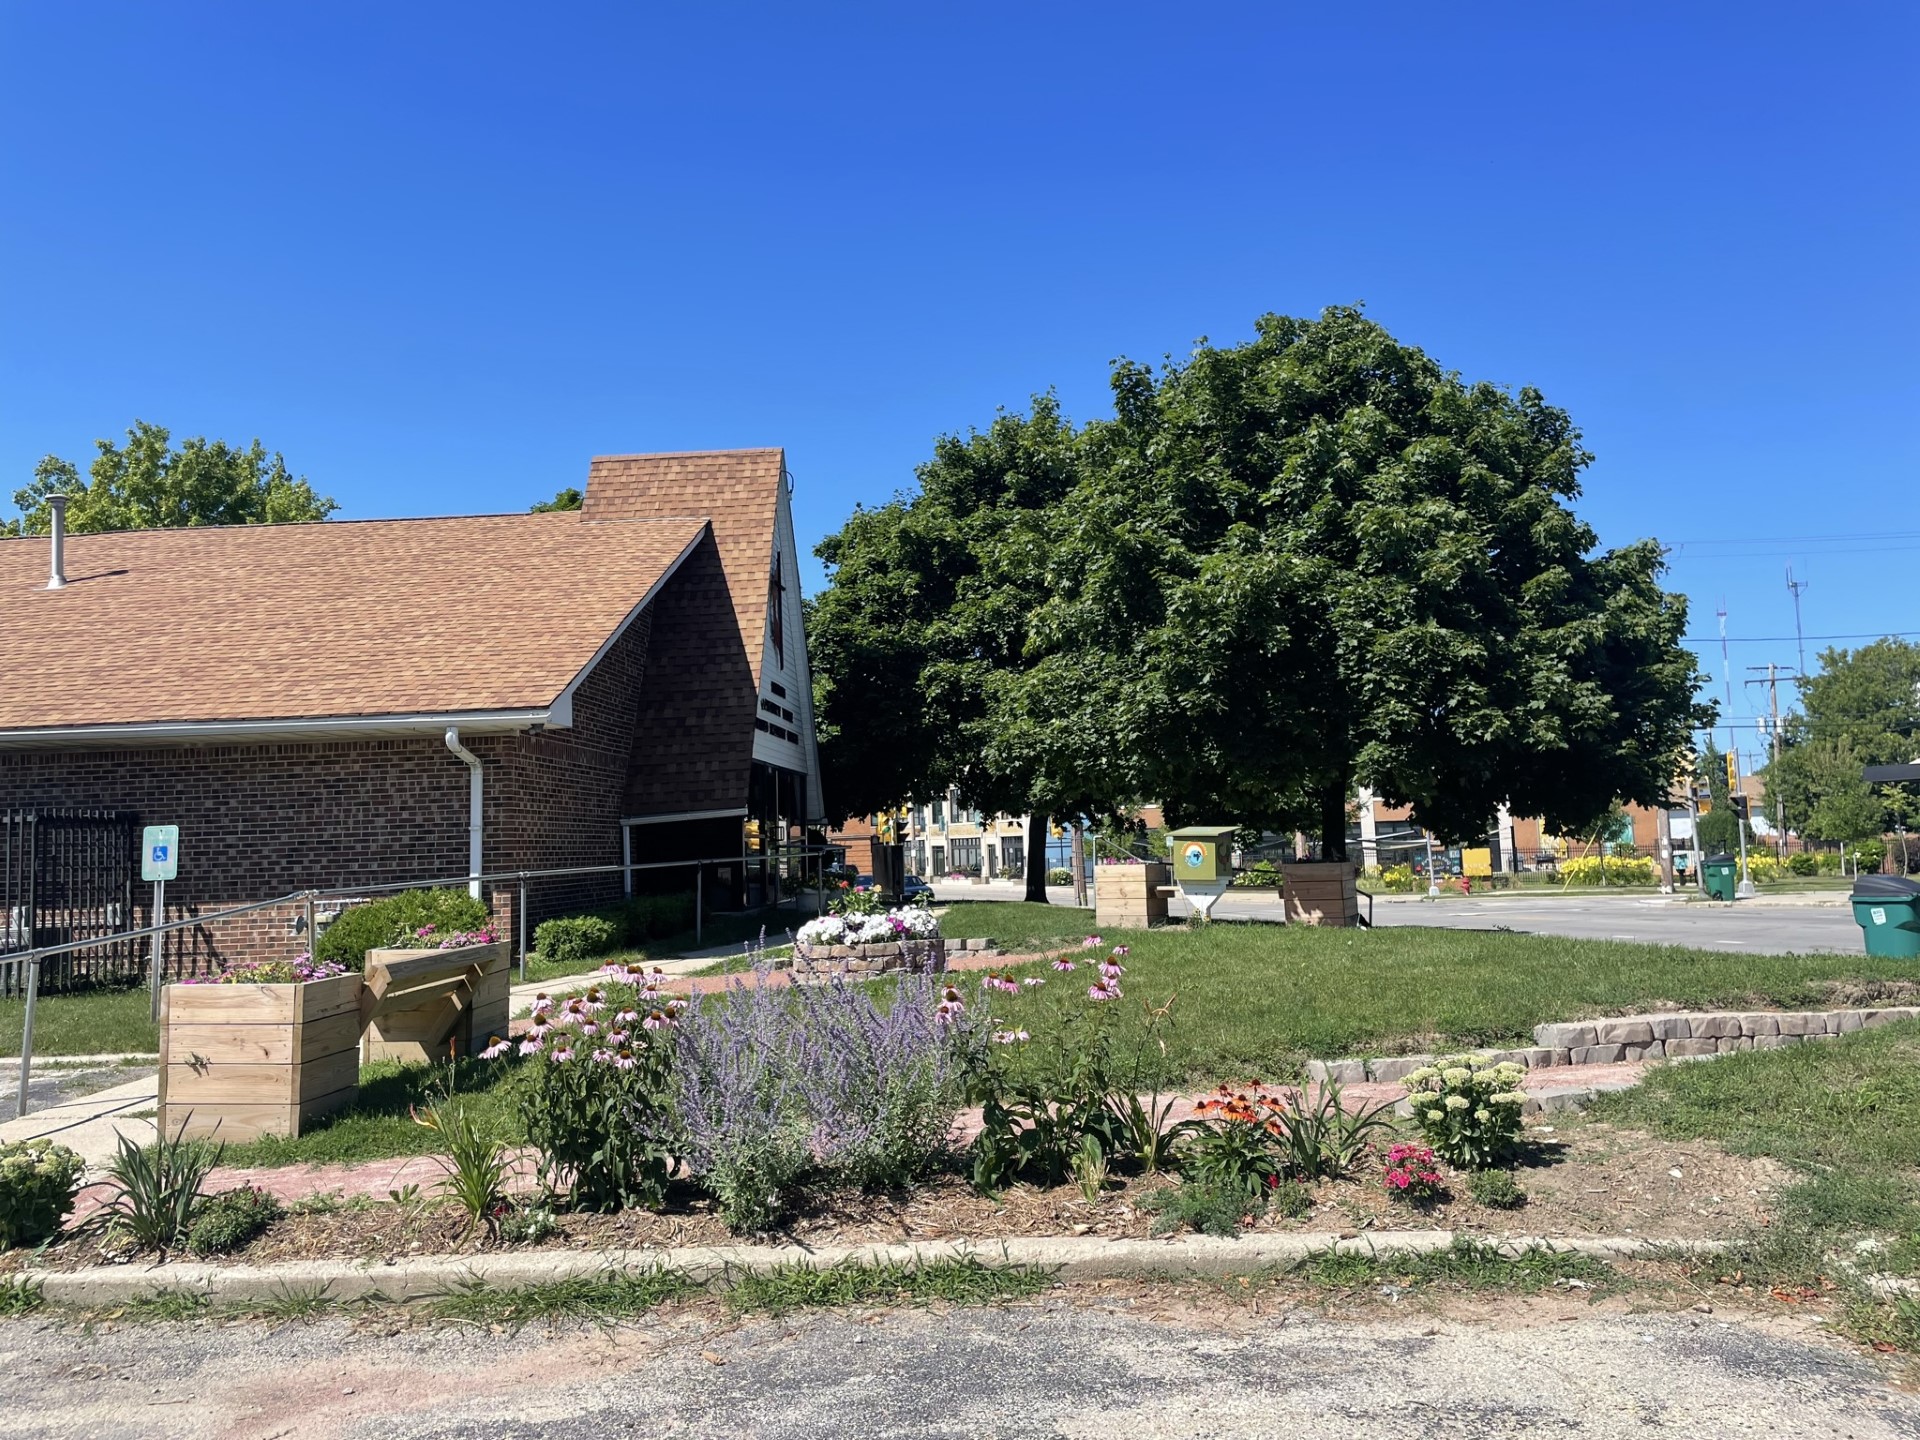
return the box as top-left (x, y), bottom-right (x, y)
top-left (0, 1294), bottom-right (1920, 1440)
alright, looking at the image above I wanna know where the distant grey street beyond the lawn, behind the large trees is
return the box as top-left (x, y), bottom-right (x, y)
top-left (937, 883), bottom-right (1864, 954)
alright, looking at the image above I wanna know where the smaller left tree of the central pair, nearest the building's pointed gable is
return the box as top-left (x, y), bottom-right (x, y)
top-left (806, 396), bottom-right (1112, 902)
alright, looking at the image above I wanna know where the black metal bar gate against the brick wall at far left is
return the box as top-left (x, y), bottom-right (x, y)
top-left (0, 808), bottom-right (146, 991)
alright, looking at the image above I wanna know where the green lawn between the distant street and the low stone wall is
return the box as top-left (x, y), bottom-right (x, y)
top-left (941, 902), bottom-right (1912, 1083)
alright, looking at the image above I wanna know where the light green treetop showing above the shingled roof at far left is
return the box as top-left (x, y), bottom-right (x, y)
top-left (6, 420), bottom-right (338, 536)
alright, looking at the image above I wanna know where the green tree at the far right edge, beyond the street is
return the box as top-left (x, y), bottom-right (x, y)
top-left (1763, 637), bottom-right (1920, 841)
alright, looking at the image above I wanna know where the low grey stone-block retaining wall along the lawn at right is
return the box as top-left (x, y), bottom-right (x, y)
top-left (1308, 1004), bottom-right (1920, 1085)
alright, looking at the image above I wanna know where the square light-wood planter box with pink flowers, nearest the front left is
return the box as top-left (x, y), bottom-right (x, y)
top-left (159, 975), bottom-right (361, 1144)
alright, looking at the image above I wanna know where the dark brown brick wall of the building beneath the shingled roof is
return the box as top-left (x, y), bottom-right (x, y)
top-left (0, 614), bottom-right (664, 973)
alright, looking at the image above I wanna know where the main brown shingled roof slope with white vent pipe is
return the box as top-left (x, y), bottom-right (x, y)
top-left (0, 509), bottom-right (707, 732)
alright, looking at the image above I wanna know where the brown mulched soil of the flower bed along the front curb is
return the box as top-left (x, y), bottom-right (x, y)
top-left (0, 1116), bottom-right (1789, 1271)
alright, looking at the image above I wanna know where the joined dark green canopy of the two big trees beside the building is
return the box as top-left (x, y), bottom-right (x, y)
top-left (810, 309), bottom-right (1703, 879)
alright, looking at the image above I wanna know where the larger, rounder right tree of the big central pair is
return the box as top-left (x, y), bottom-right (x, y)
top-left (1029, 309), bottom-right (1703, 856)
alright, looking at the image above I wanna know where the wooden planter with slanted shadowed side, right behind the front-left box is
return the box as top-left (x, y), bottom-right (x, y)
top-left (361, 941), bottom-right (513, 1060)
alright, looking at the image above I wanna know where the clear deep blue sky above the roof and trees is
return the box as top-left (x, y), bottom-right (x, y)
top-left (0, 0), bottom-right (1920, 771)
